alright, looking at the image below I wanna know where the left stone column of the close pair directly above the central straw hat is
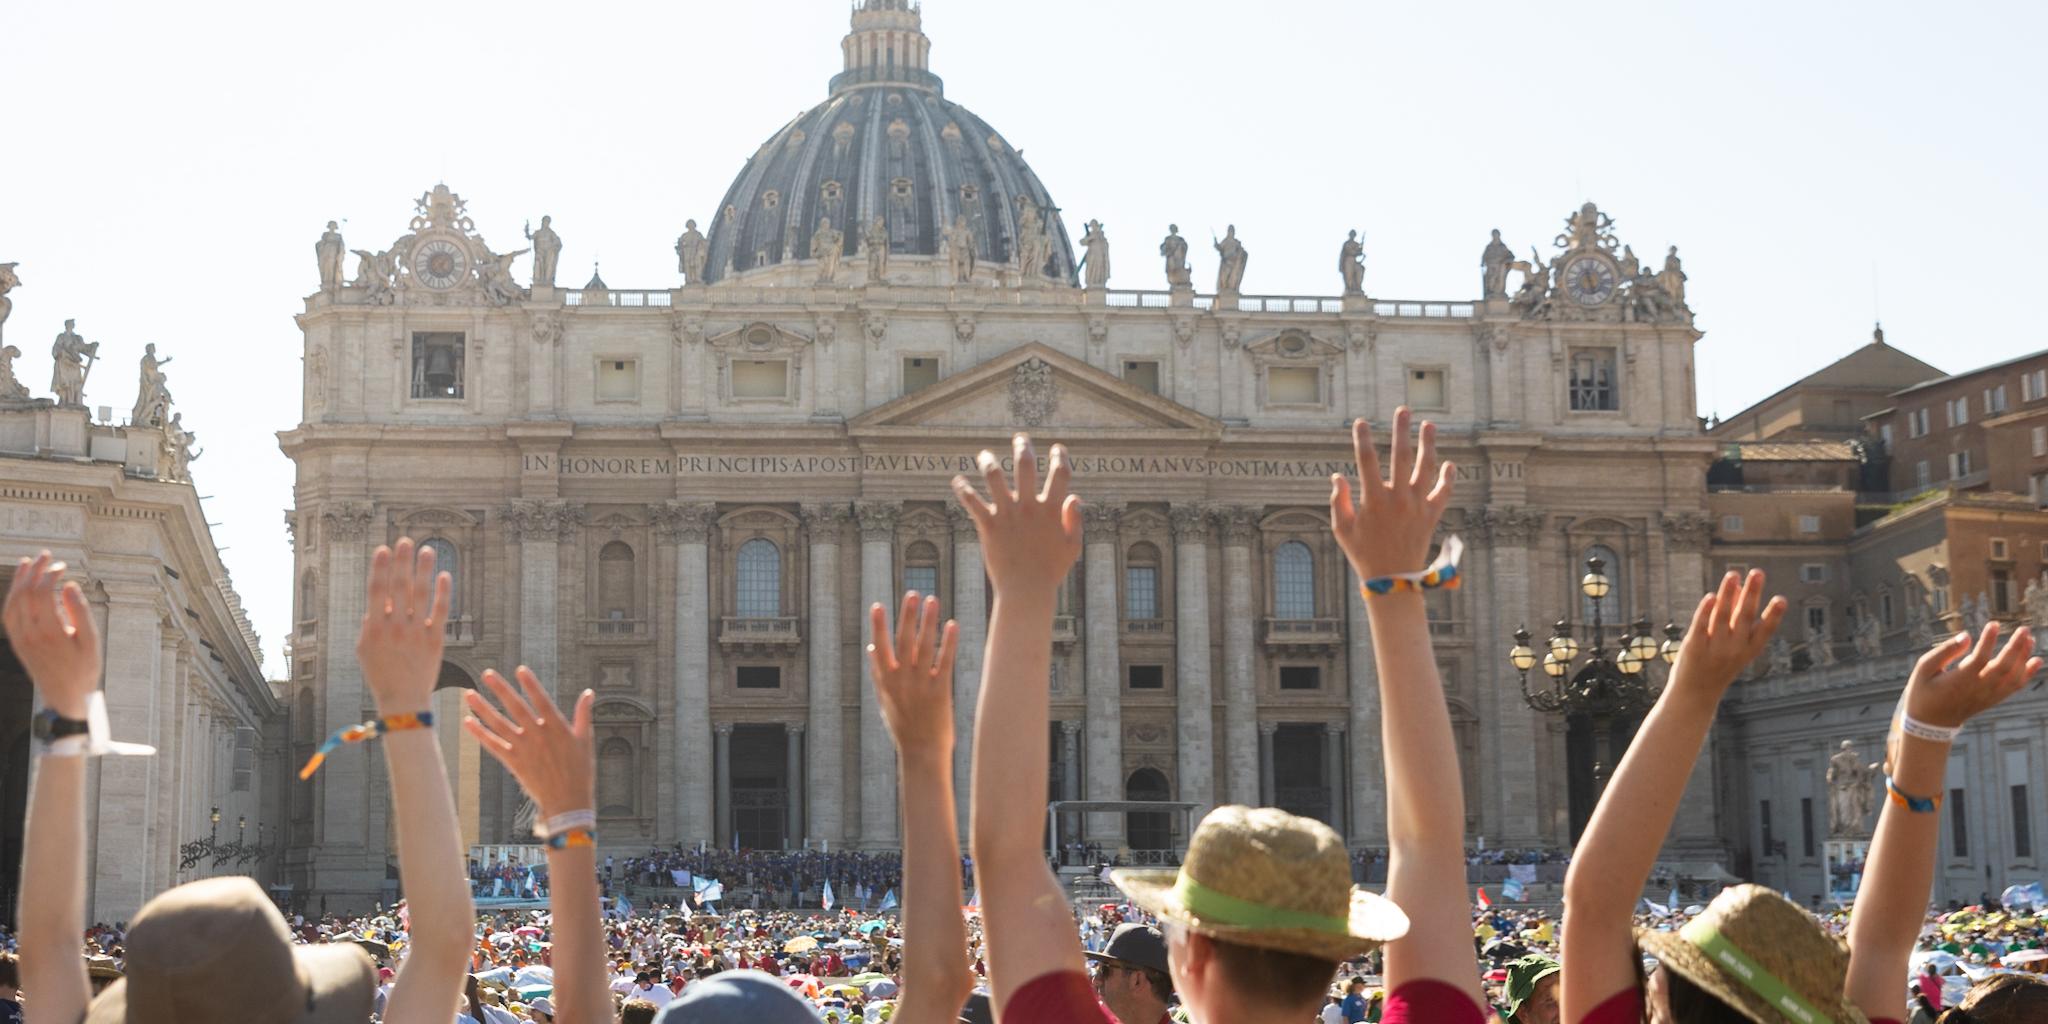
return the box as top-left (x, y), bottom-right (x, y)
top-left (1169, 504), bottom-right (1217, 821)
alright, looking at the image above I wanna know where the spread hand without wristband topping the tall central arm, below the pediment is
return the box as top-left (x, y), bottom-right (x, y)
top-left (952, 434), bottom-right (1081, 594)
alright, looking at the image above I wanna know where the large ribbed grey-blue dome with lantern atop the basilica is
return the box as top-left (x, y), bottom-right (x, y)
top-left (705, 0), bottom-right (1075, 285)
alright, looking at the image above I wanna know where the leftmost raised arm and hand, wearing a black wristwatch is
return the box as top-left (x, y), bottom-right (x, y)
top-left (0, 551), bottom-right (100, 1024)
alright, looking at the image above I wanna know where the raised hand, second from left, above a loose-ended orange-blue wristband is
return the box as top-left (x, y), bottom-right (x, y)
top-left (356, 537), bottom-right (451, 715)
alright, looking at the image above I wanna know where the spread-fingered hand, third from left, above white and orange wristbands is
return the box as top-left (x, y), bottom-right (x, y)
top-left (463, 666), bottom-right (598, 821)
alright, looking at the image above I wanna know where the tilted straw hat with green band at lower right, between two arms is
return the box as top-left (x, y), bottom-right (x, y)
top-left (1636, 885), bottom-right (1868, 1024)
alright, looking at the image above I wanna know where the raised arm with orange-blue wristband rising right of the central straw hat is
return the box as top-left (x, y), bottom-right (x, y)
top-left (1329, 408), bottom-right (1481, 1004)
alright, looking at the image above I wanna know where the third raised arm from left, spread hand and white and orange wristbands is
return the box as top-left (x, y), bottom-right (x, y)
top-left (463, 666), bottom-right (612, 1022)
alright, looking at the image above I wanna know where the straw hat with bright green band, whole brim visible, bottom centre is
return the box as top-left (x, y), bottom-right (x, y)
top-left (1110, 807), bottom-right (1407, 963)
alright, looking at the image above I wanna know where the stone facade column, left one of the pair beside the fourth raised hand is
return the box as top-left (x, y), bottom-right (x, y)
top-left (791, 504), bottom-right (847, 842)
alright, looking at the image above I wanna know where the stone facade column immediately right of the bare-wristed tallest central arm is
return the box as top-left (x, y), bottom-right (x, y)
top-left (1081, 502), bottom-right (1124, 850)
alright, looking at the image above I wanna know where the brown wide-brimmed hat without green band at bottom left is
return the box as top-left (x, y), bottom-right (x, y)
top-left (86, 877), bottom-right (377, 1024)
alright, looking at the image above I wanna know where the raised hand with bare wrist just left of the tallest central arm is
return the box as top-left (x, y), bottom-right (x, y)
top-left (868, 590), bottom-right (961, 752)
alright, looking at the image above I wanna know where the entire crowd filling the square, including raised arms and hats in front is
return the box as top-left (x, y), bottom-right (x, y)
top-left (0, 410), bottom-right (2048, 1024)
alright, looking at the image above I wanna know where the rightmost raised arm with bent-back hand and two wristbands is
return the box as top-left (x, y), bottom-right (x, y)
top-left (1847, 623), bottom-right (2042, 1016)
